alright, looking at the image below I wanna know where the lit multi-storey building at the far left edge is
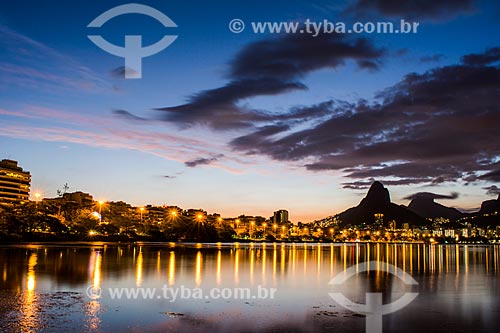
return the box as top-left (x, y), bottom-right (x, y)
top-left (0, 160), bottom-right (31, 204)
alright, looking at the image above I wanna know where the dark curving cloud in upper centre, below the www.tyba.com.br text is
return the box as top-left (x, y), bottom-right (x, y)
top-left (158, 34), bottom-right (384, 129)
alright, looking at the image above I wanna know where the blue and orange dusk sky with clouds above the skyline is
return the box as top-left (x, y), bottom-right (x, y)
top-left (0, 0), bottom-right (500, 222)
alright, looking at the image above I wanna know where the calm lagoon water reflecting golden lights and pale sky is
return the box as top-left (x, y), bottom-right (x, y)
top-left (0, 243), bottom-right (500, 332)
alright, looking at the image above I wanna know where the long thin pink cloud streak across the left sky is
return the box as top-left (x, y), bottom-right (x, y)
top-left (0, 105), bottom-right (236, 173)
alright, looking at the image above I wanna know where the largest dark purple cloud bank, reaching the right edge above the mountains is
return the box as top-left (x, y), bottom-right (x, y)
top-left (231, 46), bottom-right (500, 188)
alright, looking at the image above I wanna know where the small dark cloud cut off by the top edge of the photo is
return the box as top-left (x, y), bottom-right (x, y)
top-left (347, 0), bottom-right (476, 21)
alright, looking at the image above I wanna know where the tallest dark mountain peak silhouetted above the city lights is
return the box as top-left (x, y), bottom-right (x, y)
top-left (337, 181), bottom-right (428, 228)
